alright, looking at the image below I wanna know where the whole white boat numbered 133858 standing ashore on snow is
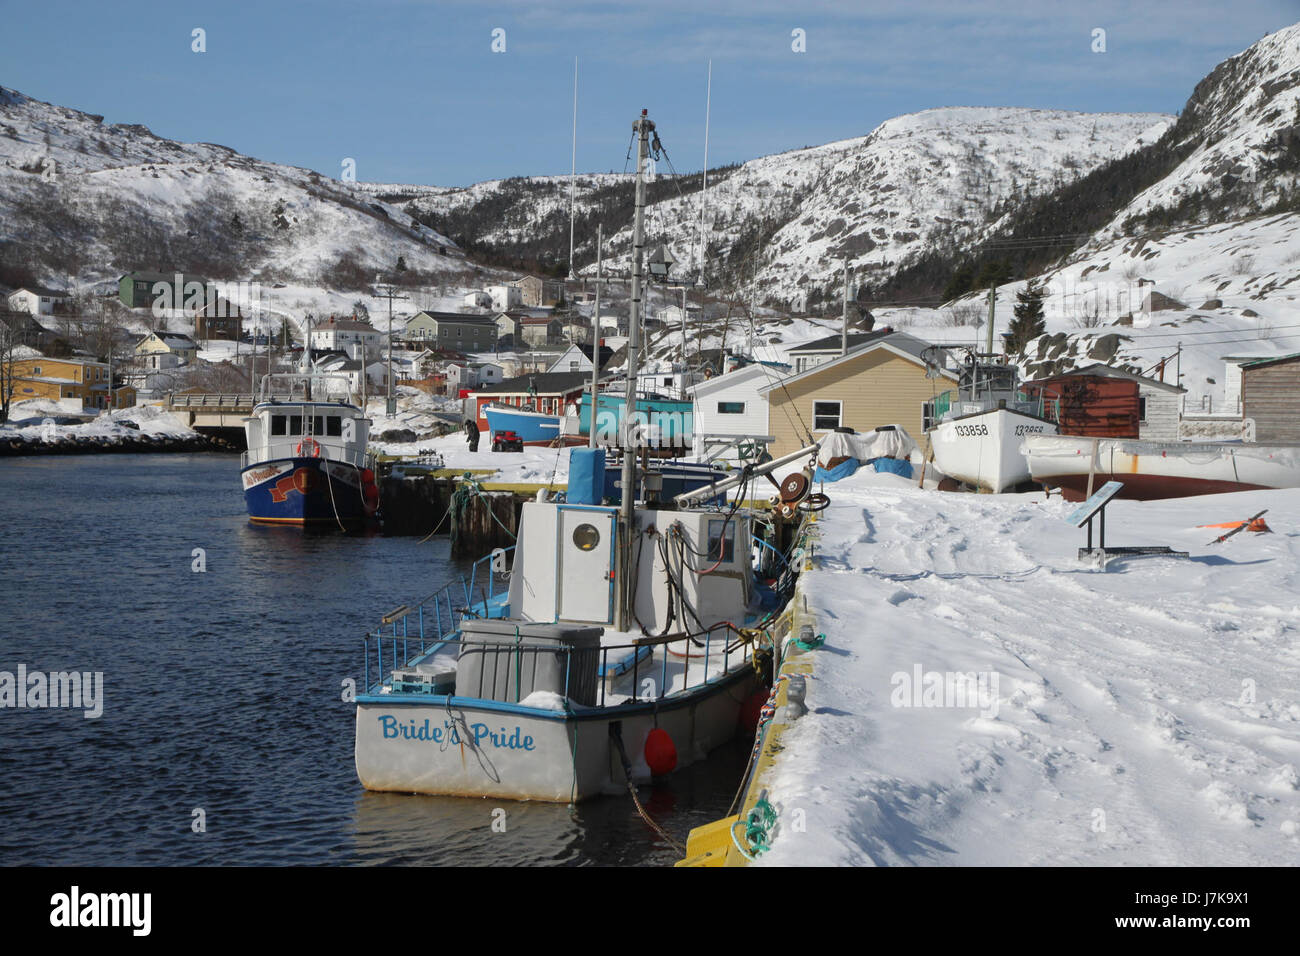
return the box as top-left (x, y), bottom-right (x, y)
top-left (927, 346), bottom-right (1057, 493)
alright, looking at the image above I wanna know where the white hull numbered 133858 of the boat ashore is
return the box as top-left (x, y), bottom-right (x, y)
top-left (930, 408), bottom-right (1057, 492)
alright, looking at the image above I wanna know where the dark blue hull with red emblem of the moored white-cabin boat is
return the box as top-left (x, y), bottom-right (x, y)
top-left (239, 458), bottom-right (374, 525)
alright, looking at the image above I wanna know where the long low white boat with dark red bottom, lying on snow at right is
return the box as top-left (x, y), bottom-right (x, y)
top-left (1023, 434), bottom-right (1300, 501)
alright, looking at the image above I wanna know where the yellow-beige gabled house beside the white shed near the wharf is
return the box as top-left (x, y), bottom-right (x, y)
top-left (759, 329), bottom-right (956, 458)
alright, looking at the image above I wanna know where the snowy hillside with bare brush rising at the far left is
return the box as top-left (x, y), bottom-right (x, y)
top-left (0, 87), bottom-right (467, 295)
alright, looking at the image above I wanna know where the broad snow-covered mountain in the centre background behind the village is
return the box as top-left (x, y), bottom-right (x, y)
top-left (403, 107), bottom-right (1174, 311)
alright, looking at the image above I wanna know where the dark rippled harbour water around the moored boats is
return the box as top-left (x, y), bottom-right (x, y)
top-left (0, 455), bottom-right (748, 865)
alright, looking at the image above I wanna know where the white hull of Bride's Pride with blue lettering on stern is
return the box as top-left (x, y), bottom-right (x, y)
top-left (356, 667), bottom-right (758, 803)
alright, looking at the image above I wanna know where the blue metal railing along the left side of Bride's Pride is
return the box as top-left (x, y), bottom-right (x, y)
top-left (361, 545), bottom-right (515, 693)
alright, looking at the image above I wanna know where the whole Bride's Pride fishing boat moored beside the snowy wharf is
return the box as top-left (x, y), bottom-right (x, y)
top-left (355, 112), bottom-right (816, 803)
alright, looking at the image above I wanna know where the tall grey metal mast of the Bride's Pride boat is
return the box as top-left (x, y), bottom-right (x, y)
top-left (618, 109), bottom-right (654, 631)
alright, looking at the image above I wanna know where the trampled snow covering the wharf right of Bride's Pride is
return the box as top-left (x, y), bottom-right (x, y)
top-left (761, 472), bottom-right (1300, 866)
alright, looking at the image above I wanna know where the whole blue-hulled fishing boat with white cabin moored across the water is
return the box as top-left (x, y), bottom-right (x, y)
top-left (239, 372), bottom-right (380, 528)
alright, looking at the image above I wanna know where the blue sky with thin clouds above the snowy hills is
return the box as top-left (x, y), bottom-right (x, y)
top-left (0, 0), bottom-right (1300, 185)
